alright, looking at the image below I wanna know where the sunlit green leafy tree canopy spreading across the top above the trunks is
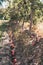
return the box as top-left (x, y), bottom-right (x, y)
top-left (2, 0), bottom-right (43, 22)
